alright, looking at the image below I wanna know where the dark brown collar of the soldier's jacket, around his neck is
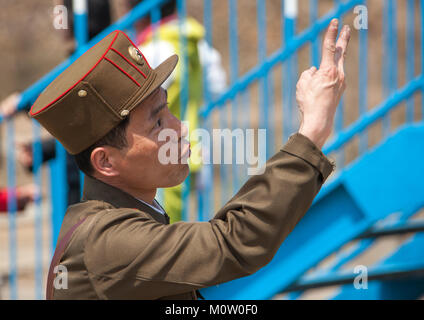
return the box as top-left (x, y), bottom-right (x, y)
top-left (82, 176), bottom-right (169, 224)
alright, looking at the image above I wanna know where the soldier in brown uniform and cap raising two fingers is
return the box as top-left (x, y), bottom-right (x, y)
top-left (30, 19), bottom-right (350, 299)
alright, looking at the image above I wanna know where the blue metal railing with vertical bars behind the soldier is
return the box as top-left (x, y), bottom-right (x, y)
top-left (0, 0), bottom-right (424, 299)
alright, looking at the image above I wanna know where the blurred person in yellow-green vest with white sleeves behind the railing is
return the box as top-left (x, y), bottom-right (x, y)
top-left (127, 0), bottom-right (226, 223)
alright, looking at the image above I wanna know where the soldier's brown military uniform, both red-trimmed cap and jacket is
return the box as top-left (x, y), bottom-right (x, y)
top-left (30, 28), bottom-right (333, 299)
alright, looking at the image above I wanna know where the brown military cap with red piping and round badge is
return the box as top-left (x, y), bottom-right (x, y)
top-left (29, 30), bottom-right (178, 155)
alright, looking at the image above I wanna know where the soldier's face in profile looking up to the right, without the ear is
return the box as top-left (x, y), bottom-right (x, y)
top-left (114, 88), bottom-right (190, 190)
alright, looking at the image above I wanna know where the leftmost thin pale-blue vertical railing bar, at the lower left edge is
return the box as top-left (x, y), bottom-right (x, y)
top-left (6, 119), bottom-right (18, 300)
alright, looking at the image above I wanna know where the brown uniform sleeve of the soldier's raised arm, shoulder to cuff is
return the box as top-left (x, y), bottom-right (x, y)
top-left (85, 134), bottom-right (333, 299)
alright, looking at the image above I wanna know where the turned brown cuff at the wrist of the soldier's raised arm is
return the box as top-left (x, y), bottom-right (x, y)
top-left (281, 133), bottom-right (335, 181)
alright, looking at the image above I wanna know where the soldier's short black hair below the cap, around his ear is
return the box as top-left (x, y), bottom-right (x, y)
top-left (75, 117), bottom-right (129, 177)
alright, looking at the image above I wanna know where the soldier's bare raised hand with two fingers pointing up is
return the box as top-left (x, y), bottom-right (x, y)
top-left (296, 19), bottom-right (350, 149)
